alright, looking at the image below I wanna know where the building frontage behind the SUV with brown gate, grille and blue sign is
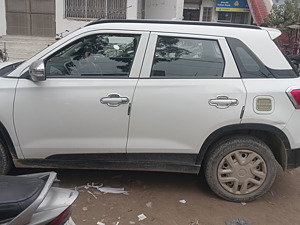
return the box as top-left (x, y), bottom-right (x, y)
top-left (0, 0), bottom-right (276, 37)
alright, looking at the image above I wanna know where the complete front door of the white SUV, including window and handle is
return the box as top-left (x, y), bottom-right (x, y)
top-left (14, 30), bottom-right (149, 160)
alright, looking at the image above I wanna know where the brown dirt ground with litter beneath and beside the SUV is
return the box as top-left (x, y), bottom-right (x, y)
top-left (39, 165), bottom-right (300, 225)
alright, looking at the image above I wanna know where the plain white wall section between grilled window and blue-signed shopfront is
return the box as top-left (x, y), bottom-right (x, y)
top-left (145, 0), bottom-right (184, 20)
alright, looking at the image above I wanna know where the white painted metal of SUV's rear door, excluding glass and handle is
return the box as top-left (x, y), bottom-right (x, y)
top-left (127, 32), bottom-right (246, 158)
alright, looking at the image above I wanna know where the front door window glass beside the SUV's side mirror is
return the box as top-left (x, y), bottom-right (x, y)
top-left (46, 34), bottom-right (140, 77)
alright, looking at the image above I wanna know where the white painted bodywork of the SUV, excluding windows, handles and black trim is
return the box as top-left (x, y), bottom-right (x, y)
top-left (0, 22), bottom-right (300, 169)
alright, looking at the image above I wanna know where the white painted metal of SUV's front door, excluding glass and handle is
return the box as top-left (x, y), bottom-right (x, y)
top-left (14, 30), bottom-right (148, 158)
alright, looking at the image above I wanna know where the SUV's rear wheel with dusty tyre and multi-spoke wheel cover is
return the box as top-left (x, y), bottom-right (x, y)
top-left (204, 136), bottom-right (277, 202)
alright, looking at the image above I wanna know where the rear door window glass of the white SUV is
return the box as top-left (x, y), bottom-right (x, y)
top-left (151, 37), bottom-right (224, 78)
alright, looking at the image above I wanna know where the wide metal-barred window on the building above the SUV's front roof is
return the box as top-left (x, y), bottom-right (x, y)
top-left (65, 0), bottom-right (127, 19)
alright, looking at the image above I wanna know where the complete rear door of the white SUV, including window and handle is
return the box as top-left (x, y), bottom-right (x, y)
top-left (127, 33), bottom-right (246, 165)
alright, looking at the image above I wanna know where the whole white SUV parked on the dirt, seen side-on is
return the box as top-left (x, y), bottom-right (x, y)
top-left (0, 20), bottom-right (300, 201)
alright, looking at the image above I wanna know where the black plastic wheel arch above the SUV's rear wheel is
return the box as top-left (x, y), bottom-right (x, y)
top-left (196, 124), bottom-right (290, 170)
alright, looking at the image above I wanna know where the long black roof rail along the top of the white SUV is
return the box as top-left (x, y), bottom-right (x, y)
top-left (85, 19), bottom-right (261, 29)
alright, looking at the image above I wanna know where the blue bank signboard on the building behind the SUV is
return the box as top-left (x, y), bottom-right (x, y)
top-left (216, 0), bottom-right (250, 12)
